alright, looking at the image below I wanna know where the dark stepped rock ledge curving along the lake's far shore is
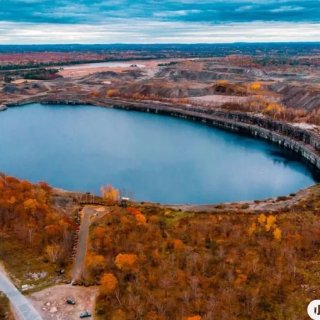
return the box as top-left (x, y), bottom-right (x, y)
top-left (8, 95), bottom-right (320, 170)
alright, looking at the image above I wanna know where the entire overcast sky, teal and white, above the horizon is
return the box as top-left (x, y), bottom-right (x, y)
top-left (0, 0), bottom-right (320, 44)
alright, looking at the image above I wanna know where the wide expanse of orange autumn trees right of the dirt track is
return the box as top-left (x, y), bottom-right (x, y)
top-left (89, 187), bottom-right (320, 320)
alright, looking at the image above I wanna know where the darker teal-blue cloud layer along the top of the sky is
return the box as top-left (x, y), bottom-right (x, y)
top-left (0, 0), bottom-right (320, 24)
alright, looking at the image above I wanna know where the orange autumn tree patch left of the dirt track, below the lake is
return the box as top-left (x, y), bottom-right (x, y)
top-left (0, 174), bottom-right (74, 263)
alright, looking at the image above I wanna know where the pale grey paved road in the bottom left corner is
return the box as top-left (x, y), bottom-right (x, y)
top-left (0, 269), bottom-right (42, 320)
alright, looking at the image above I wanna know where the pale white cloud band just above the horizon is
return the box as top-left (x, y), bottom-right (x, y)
top-left (0, 19), bottom-right (320, 44)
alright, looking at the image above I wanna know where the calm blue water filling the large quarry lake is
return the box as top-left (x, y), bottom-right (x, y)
top-left (0, 104), bottom-right (315, 204)
